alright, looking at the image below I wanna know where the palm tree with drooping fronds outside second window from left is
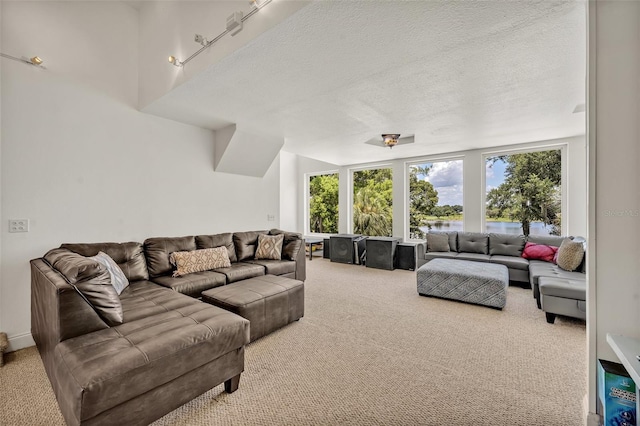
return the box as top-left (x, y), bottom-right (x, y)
top-left (353, 187), bottom-right (392, 236)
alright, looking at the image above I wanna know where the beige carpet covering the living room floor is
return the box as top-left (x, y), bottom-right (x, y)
top-left (0, 258), bottom-right (587, 426)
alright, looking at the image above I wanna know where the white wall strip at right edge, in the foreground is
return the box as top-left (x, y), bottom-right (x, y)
top-left (587, 1), bottom-right (640, 412)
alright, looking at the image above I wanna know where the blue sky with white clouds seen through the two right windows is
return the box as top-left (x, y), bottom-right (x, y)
top-left (424, 160), bottom-right (505, 206)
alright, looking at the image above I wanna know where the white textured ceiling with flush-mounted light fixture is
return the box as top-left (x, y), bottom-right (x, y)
top-left (145, 1), bottom-right (586, 165)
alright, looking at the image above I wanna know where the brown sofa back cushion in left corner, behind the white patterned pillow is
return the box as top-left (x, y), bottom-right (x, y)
top-left (60, 242), bottom-right (149, 281)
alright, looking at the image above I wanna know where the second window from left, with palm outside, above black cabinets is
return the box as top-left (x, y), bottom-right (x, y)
top-left (353, 168), bottom-right (393, 237)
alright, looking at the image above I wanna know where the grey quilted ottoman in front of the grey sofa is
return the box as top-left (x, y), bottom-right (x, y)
top-left (416, 259), bottom-right (509, 309)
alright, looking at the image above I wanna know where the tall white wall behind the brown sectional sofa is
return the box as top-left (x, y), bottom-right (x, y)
top-left (0, 1), bottom-right (280, 349)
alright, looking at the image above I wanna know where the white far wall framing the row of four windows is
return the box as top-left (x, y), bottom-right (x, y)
top-left (298, 136), bottom-right (587, 238)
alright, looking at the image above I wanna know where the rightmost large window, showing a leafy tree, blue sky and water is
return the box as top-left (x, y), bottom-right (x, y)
top-left (485, 149), bottom-right (562, 235)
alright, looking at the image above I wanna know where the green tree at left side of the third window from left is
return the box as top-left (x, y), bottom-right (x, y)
top-left (409, 165), bottom-right (438, 238)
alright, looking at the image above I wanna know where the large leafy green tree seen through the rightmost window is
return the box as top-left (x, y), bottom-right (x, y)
top-left (487, 150), bottom-right (562, 235)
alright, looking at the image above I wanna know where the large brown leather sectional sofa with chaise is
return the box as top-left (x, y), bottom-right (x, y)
top-left (31, 230), bottom-right (305, 425)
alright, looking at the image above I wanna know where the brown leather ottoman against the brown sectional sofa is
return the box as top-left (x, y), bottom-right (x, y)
top-left (202, 275), bottom-right (304, 342)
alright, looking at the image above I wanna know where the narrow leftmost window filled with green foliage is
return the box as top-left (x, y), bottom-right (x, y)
top-left (309, 173), bottom-right (339, 234)
